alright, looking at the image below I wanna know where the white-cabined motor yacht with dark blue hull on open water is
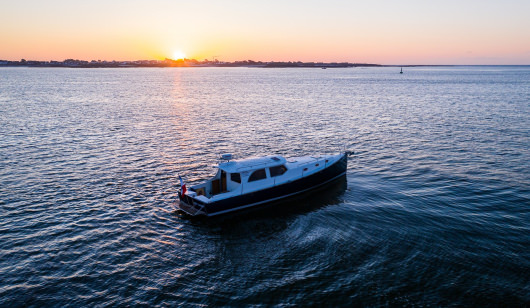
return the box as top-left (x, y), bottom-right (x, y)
top-left (177, 151), bottom-right (353, 217)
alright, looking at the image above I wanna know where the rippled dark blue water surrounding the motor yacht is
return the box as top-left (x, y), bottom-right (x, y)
top-left (0, 67), bottom-right (530, 307)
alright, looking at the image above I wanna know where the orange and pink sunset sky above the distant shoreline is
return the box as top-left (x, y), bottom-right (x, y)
top-left (0, 0), bottom-right (530, 65)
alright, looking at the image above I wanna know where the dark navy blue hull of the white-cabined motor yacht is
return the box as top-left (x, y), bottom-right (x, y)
top-left (179, 154), bottom-right (348, 216)
